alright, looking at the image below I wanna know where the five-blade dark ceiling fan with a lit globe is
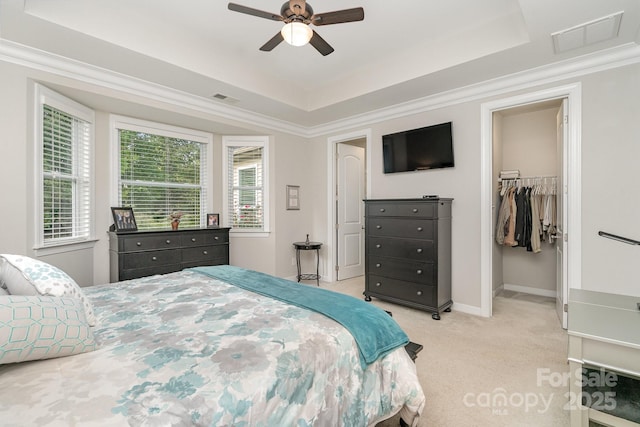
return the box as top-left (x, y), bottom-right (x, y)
top-left (229, 0), bottom-right (364, 56)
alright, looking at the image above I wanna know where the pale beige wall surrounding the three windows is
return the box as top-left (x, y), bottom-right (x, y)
top-left (0, 61), bottom-right (324, 286)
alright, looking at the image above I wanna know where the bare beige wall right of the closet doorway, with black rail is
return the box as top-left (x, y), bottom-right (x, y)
top-left (581, 64), bottom-right (640, 296)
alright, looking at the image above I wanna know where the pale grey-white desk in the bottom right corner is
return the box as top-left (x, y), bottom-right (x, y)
top-left (568, 289), bottom-right (640, 427)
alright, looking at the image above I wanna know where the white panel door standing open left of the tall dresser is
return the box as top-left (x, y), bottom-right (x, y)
top-left (336, 144), bottom-right (365, 280)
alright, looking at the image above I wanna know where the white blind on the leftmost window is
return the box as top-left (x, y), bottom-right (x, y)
top-left (42, 104), bottom-right (92, 246)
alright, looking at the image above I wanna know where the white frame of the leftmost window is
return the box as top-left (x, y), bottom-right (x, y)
top-left (33, 83), bottom-right (96, 255)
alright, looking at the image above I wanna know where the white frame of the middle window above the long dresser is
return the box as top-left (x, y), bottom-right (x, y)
top-left (109, 114), bottom-right (213, 231)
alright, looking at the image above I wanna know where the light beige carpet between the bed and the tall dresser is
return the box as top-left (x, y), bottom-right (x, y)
top-left (314, 277), bottom-right (569, 427)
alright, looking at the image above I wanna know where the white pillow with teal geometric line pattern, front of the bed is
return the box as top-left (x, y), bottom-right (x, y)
top-left (0, 295), bottom-right (96, 364)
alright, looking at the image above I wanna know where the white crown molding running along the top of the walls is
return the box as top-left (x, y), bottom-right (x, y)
top-left (0, 38), bottom-right (640, 138)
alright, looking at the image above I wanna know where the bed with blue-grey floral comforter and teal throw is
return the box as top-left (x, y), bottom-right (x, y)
top-left (0, 258), bottom-right (425, 426)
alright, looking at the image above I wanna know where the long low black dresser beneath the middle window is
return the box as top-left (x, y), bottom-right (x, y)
top-left (109, 228), bottom-right (229, 282)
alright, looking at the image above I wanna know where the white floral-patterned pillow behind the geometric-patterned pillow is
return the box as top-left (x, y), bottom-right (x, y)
top-left (0, 254), bottom-right (96, 326)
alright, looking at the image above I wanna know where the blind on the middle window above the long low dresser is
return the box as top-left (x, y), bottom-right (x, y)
top-left (118, 129), bottom-right (207, 230)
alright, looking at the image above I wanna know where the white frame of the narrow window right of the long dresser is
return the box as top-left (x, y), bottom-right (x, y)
top-left (221, 135), bottom-right (271, 237)
